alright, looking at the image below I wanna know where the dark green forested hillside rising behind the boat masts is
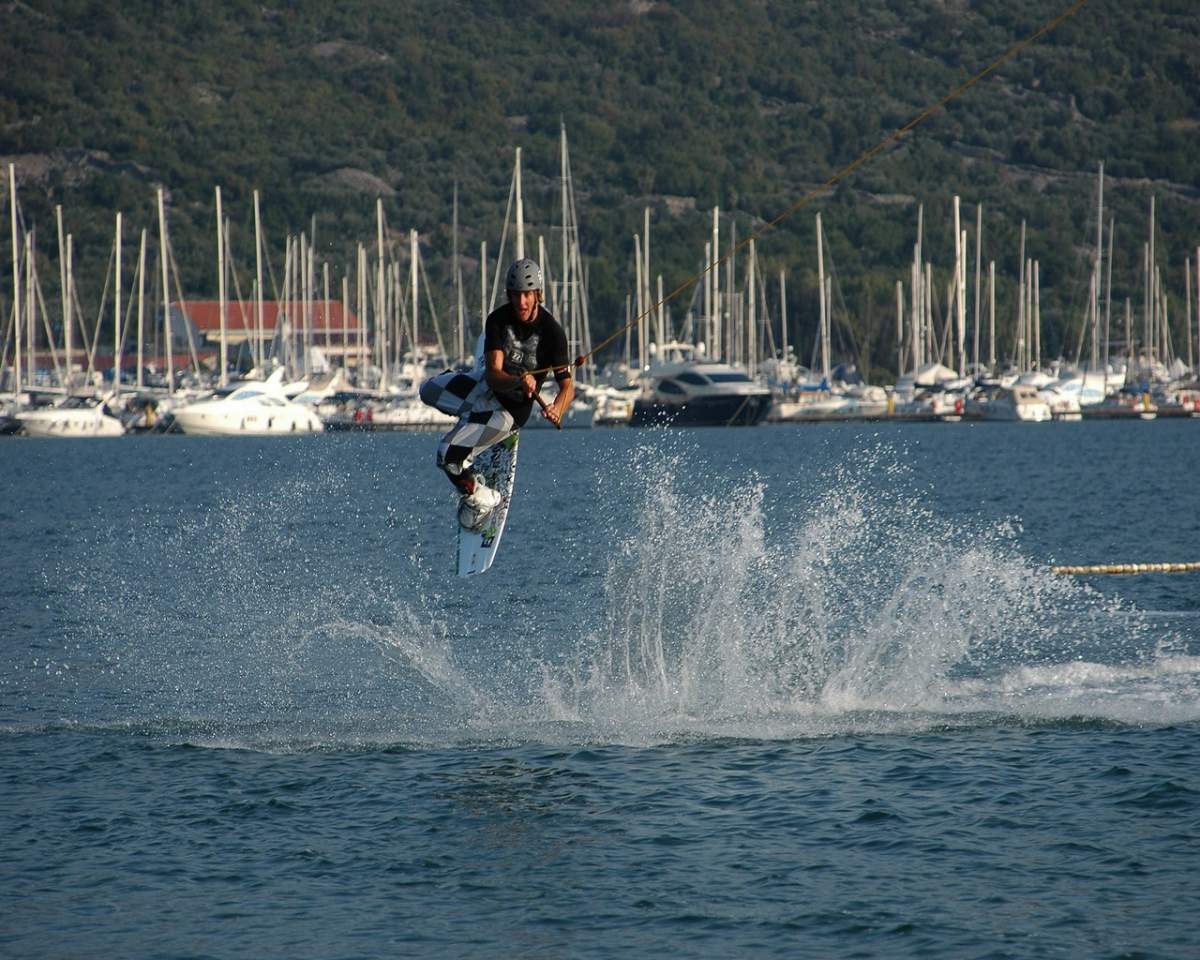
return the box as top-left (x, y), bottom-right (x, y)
top-left (0, 0), bottom-right (1200, 366)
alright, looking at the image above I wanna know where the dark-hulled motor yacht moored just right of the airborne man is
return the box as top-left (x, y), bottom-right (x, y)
top-left (630, 344), bottom-right (772, 426)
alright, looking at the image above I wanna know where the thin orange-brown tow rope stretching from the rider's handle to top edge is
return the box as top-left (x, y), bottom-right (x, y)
top-left (540, 0), bottom-right (1090, 376)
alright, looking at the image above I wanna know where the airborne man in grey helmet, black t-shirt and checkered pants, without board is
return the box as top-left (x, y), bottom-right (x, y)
top-left (421, 258), bottom-right (575, 516)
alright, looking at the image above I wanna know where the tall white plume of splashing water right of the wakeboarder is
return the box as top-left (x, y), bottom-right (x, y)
top-left (544, 446), bottom-right (1200, 732)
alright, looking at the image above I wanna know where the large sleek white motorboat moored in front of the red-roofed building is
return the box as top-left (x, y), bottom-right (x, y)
top-left (173, 372), bottom-right (325, 437)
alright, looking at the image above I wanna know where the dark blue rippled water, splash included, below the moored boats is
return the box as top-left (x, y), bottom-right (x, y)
top-left (0, 421), bottom-right (1200, 958)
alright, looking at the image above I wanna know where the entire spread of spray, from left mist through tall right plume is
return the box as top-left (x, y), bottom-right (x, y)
top-left (44, 432), bottom-right (1200, 749)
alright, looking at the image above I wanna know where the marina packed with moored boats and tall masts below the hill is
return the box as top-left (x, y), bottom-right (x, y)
top-left (0, 153), bottom-right (1200, 437)
